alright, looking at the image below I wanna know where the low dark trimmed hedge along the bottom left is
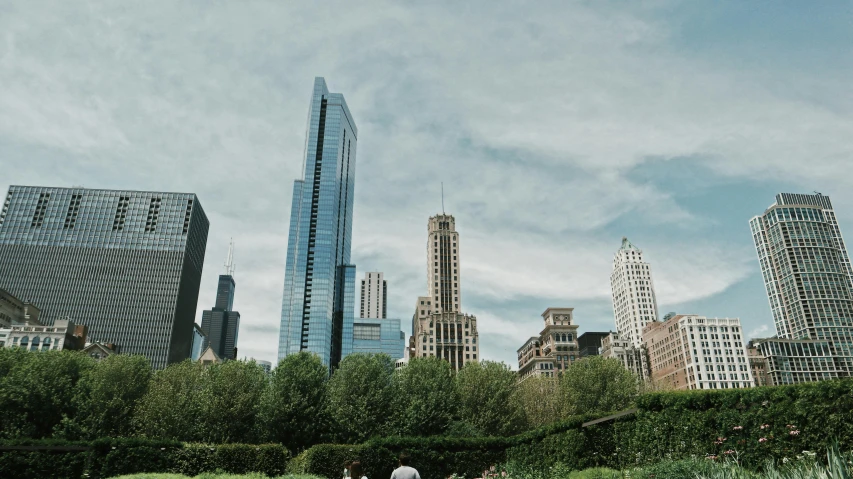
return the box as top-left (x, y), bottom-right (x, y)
top-left (0, 439), bottom-right (290, 479)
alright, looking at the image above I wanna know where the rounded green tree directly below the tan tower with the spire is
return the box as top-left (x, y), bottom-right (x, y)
top-left (390, 357), bottom-right (459, 436)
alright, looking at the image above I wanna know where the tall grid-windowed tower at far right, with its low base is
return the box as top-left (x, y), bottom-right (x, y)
top-left (749, 193), bottom-right (853, 384)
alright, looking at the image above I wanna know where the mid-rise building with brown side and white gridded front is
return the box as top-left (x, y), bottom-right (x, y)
top-left (643, 314), bottom-right (755, 389)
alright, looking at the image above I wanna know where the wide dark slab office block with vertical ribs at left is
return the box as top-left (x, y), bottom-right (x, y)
top-left (0, 186), bottom-right (209, 368)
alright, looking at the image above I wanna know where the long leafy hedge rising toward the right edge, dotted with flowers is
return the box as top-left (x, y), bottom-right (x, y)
top-left (289, 379), bottom-right (853, 479)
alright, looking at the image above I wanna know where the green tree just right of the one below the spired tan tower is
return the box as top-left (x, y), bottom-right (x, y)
top-left (456, 361), bottom-right (524, 436)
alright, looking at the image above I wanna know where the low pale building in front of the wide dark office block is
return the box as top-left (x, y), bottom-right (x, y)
top-left (2, 319), bottom-right (87, 351)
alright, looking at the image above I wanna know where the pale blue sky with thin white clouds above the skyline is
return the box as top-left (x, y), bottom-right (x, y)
top-left (0, 0), bottom-right (853, 368)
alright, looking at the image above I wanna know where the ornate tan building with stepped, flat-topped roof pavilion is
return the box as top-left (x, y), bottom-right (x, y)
top-left (517, 308), bottom-right (581, 381)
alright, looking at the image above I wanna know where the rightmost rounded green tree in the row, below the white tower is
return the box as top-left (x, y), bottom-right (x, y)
top-left (560, 356), bottom-right (637, 414)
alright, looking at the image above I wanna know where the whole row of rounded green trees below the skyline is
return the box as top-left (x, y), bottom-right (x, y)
top-left (0, 349), bottom-right (637, 451)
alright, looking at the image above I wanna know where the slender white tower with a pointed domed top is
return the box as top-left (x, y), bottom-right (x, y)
top-left (610, 237), bottom-right (658, 348)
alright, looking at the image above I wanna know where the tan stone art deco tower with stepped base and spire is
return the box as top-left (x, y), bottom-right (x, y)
top-left (409, 214), bottom-right (480, 370)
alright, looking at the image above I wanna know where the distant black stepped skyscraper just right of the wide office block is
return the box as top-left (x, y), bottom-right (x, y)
top-left (201, 274), bottom-right (240, 359)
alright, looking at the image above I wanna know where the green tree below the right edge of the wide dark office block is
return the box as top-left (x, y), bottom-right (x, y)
top-left (133, 359), bottom-right (205, 441)
